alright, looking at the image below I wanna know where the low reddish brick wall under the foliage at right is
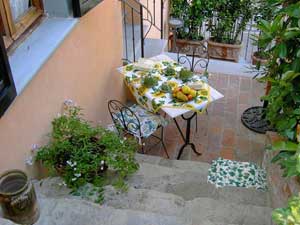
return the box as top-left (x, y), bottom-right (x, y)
top-left (263, 132), bottom-right (300, 208)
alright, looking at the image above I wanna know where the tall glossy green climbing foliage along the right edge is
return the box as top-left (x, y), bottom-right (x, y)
top-left (258, 0), bottom-right (300, 176)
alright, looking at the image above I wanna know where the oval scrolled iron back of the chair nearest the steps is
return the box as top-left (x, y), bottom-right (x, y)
top-left (108, 100), bottom-right (142, 137)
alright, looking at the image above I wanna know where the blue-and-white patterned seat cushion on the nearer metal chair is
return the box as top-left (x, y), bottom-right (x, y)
top-left (116, 105), bottom-right (168, 138)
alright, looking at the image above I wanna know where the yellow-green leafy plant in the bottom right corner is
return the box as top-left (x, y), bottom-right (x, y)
top-left (272, 195), bottom-right (300, 225)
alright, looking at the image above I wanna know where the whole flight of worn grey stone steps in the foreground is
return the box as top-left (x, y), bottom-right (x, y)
top-left (0, 154), bottom-right (272, 225)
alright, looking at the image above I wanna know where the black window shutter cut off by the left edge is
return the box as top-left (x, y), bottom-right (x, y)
top-left (0, 37), bottom-right (17, 117)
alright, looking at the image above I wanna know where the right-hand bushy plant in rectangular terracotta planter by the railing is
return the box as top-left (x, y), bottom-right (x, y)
top-left (207, 0), bottom-right (253, 62)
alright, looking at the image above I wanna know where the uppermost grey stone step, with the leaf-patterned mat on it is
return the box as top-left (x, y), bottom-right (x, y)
top-left (129, 160), bottom-right (269, 206)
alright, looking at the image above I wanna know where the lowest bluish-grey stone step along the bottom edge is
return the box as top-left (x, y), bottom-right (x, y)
top-left (35, 198), bottom-right (192, 225)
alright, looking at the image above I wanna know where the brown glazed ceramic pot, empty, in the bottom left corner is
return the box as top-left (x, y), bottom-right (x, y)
top-left (0, 170), bottom-right (40, 225)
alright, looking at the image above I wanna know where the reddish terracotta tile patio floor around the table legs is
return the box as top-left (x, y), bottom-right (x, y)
top-left (147, 74), bottom-right (265, 164)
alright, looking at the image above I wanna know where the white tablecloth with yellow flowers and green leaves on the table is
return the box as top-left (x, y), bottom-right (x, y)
top-left (121, 57), bottom-right (211, 115)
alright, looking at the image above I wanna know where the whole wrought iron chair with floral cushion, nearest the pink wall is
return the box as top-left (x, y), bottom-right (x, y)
top-left (108, 100), bottom-right (170, 158)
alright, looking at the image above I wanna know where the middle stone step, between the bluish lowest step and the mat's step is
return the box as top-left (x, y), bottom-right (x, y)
top-left (105, 185), bottom-right (272, 225)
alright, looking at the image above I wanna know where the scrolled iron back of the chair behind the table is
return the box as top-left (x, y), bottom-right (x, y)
top-left (176, 41), bottom-right (209, 72)
